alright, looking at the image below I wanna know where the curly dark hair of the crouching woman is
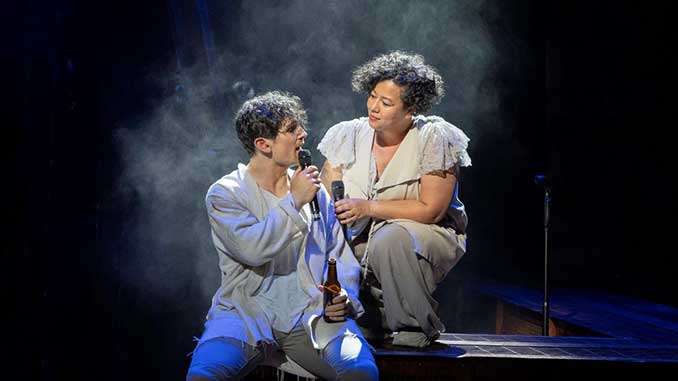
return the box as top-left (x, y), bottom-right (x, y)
top-left (351, 50), bottom-right (445, 114)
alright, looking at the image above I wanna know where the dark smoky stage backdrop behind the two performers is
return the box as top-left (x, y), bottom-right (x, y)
top-left (11, 0), bottom-right (678, 380)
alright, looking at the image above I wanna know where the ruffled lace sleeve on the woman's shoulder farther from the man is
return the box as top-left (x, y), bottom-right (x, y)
top-left (419, 116), bottom-right (471, 175)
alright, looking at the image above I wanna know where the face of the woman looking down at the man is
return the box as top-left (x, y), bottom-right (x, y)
top-left (367, 79), bottom-right (413, 131)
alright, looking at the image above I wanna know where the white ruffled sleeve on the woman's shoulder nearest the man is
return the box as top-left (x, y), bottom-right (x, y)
top-left (318, 119), bottom-right (360, 168)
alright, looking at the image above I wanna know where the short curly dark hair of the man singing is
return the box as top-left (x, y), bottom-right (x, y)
top-left (235, 90), bottom-right (308, 156)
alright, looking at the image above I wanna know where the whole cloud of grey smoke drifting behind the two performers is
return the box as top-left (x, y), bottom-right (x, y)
top-left (116, 0), bottom-right (497, 309)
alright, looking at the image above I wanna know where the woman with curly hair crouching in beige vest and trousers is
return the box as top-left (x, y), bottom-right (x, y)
top-left (318, 51), bottom-right (471, 347)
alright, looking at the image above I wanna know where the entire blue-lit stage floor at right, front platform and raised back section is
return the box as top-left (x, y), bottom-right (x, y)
top-left (256, 283), bottom-right (678, 381)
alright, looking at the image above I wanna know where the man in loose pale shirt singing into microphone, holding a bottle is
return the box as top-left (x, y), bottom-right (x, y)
top-left (187, 91), bottom-right (378, 381)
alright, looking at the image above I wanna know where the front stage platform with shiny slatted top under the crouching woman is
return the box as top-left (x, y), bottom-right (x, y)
top-left (376, 333), bottom-right (678, 381)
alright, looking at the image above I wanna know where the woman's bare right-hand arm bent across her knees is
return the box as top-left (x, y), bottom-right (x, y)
top-left (335, 171), bottom-right (457, 224)
